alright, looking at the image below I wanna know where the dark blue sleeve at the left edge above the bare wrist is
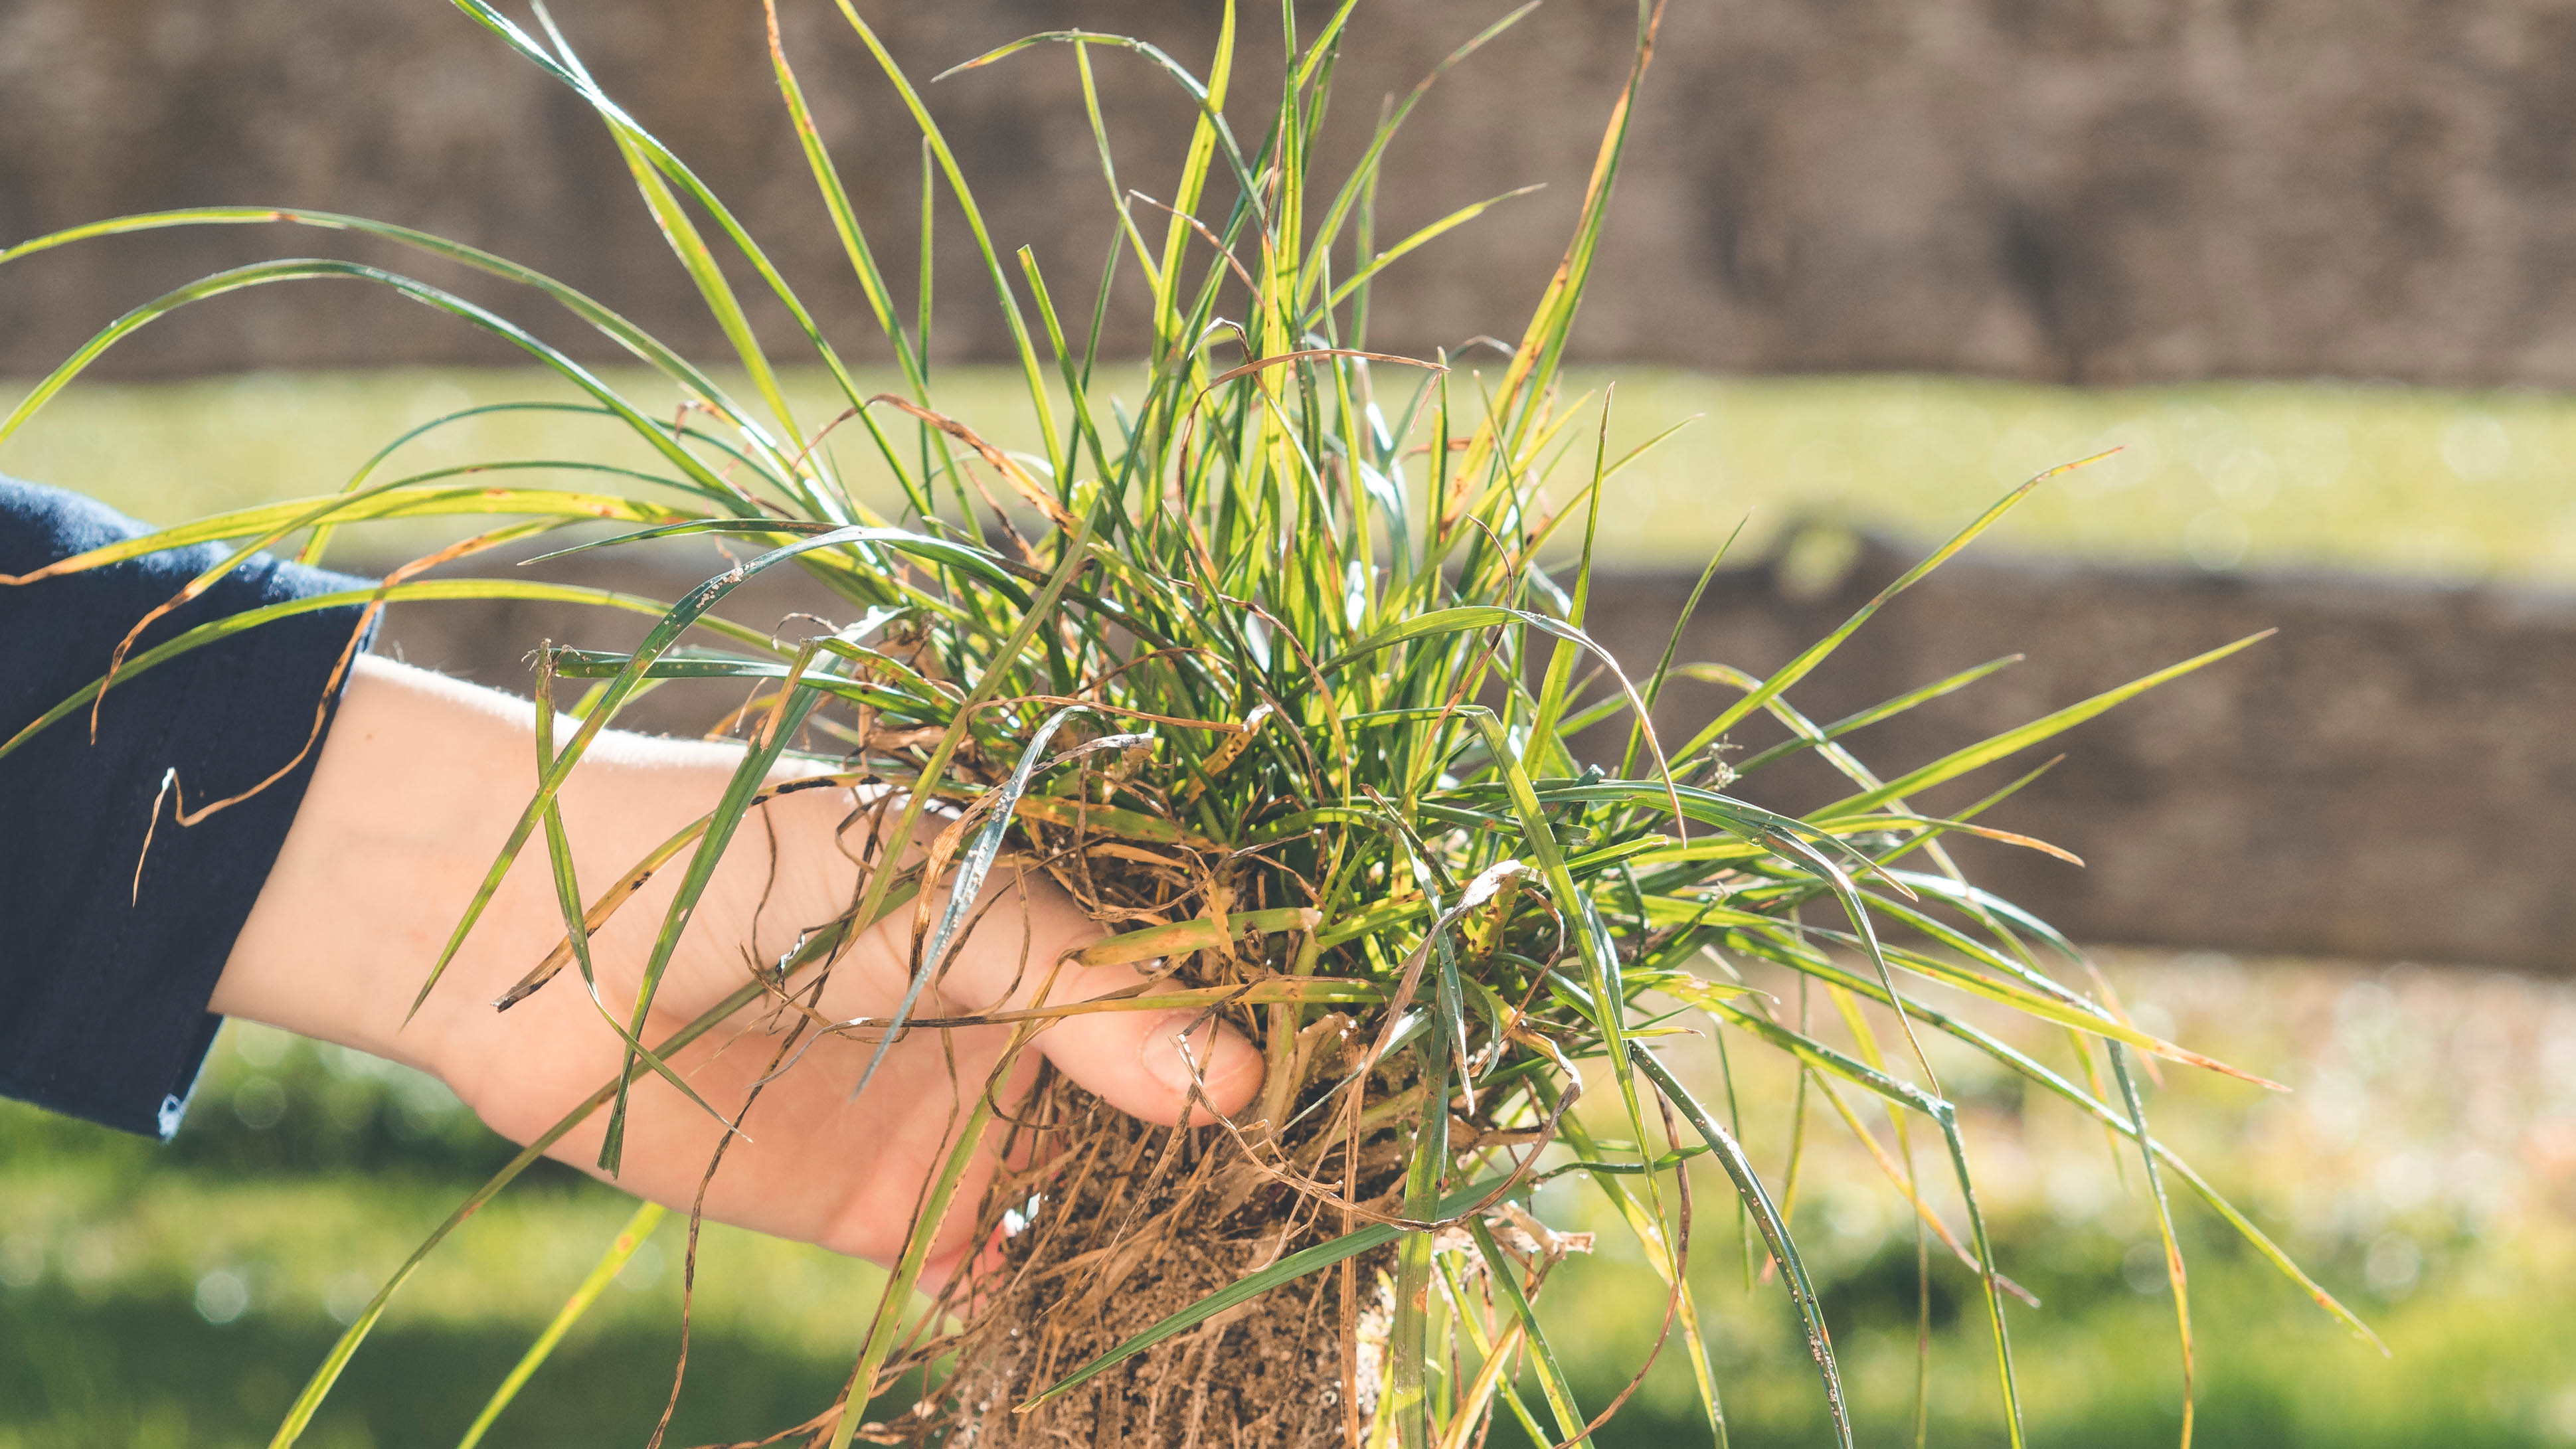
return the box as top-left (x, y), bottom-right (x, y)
top-left (0, 479), bottom-right (369, 1138)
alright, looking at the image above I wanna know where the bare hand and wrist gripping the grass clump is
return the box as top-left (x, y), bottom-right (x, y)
top-left (214, 659), bottom-right (1260, 1258)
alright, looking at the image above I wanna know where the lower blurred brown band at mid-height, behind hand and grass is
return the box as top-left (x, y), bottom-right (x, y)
top-left (381, 528), bottom-right (2576, 973)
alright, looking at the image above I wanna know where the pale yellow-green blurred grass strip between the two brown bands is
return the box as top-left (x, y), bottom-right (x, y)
top-left (0, 358), bottom-right (2576, 587)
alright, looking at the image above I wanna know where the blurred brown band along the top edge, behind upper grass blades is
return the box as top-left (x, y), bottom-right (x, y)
top-left (15, 0), bottom-right (2576, 386)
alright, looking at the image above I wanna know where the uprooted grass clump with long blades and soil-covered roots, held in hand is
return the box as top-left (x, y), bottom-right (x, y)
top-left (0, 0), bottom-right (2342, 1449)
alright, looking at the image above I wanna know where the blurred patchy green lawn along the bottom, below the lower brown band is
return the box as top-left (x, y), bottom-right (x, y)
top-left (0, 955), bottom-right (2576, 1449)
